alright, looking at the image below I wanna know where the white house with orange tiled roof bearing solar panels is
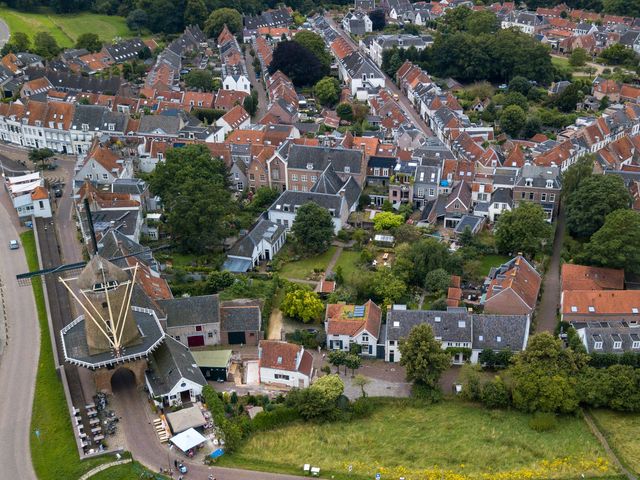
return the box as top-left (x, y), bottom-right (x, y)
top-left (324, 300), bottom-right (382, 357)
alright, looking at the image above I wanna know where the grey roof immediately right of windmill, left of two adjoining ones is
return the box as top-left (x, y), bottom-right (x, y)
top-left (157, 295), bottom-right (220, 327)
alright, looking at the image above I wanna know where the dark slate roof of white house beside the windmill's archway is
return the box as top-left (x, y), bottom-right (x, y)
top-left (145, 336), bottom-right (207, 395)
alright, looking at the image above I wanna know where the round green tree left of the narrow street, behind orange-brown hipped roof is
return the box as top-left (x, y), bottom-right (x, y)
top-left (495, 202), bottom-right (551, 258)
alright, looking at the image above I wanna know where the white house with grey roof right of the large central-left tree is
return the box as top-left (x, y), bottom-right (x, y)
top-left (223, 219), bottom-right (287, 273)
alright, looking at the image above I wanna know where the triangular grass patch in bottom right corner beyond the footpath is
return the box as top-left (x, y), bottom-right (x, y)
top-left (591, 410), bottom-right (640, 475)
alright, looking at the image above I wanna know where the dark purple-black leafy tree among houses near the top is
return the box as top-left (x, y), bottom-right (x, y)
top-left (269, 41), bottom-right (329, 87)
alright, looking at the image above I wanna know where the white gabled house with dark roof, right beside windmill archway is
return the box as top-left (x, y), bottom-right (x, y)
top-left (144, 336), bottom-right (207, 407)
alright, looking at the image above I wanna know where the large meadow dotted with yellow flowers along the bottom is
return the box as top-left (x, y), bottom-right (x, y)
top-left (221, 399), bottom-right (615, 480)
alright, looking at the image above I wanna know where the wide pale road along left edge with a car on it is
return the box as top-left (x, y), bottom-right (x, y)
top-left (0, 199), bottom-right (40, 480)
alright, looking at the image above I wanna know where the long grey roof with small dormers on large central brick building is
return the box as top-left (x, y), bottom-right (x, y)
top-left (287, 144), bottom-right (362, 174)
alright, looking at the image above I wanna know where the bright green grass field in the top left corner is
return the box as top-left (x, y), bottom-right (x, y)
top-left (0, 7), bottom-right (133, 47)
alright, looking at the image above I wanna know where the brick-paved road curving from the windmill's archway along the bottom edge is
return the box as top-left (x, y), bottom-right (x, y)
top-left (117, 389), bottom-right (306, 480)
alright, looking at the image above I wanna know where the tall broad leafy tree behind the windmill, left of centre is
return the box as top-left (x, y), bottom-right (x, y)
top-left (150, 145), bottom-right (235, 253)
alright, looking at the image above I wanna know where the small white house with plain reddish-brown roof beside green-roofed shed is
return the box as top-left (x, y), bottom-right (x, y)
top-left (258, 340), bottom-right (313, 388)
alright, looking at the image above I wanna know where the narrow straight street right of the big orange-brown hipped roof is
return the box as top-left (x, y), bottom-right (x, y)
top-left (536, 204), bottom-right (565, 332)
